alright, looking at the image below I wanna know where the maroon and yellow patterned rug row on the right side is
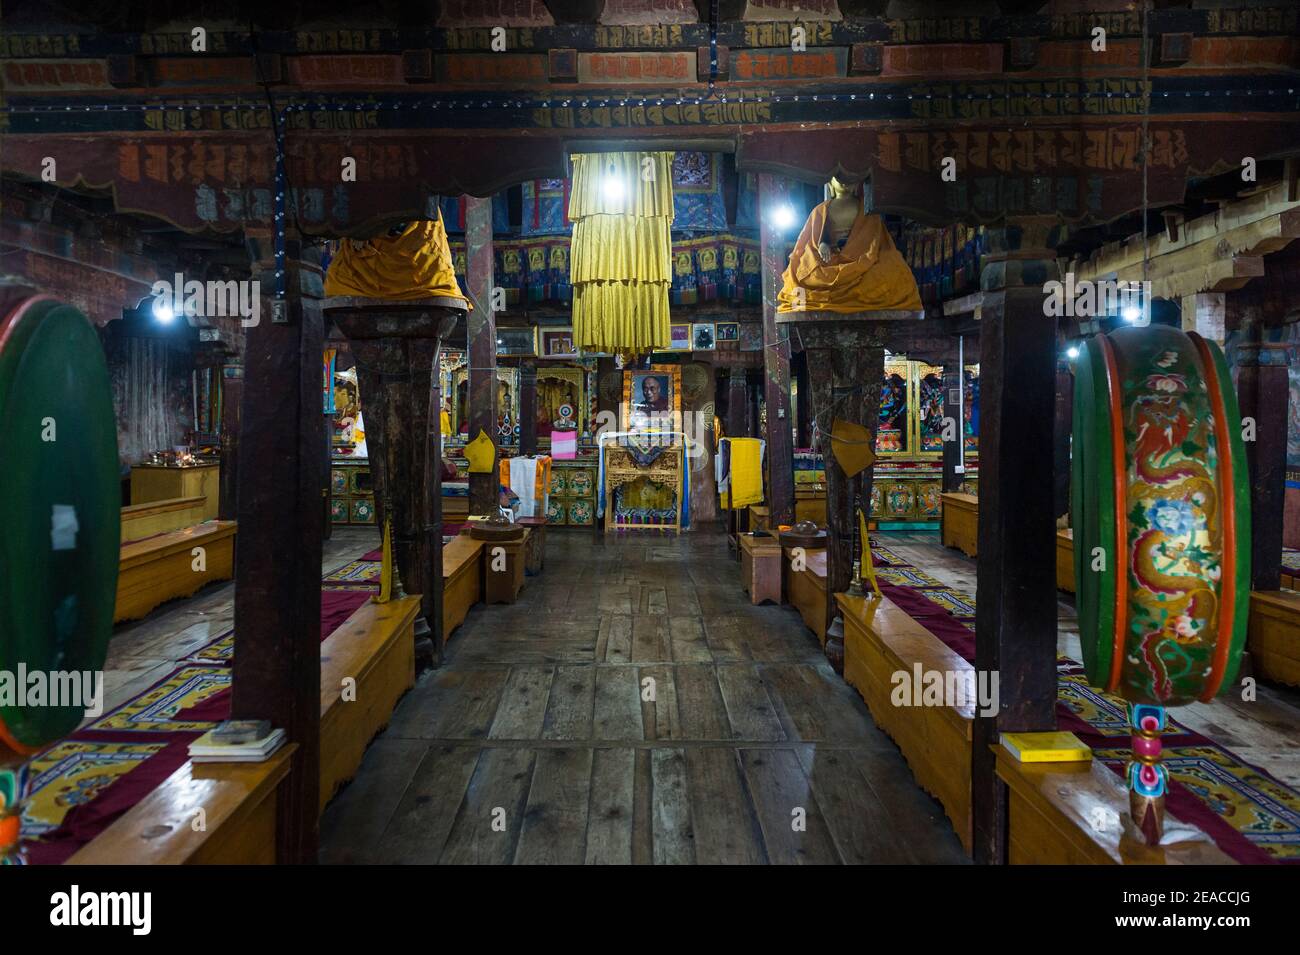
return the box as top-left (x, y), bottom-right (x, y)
top-left (871, 539), bottom-right (1300, 864)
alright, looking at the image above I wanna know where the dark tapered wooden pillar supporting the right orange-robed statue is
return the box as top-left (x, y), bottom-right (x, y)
top-left (781, 312), bottom-right (907, 660)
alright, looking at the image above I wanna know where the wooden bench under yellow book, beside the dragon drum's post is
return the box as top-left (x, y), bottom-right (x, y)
top-left (993, 746), bottom-right (1235, 865)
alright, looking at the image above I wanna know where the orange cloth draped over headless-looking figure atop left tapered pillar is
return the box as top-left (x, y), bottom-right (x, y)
top-left (325, 212), bottom-right (472, 308)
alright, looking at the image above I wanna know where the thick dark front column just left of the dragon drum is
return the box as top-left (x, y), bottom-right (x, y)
top-left (971, 222), bottom-right (1057, 863)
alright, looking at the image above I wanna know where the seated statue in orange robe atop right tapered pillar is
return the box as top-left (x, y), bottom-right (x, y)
top-left (777, 178), bottom-right (922, 312)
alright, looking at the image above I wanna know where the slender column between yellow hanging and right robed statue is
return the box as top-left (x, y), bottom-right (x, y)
top-left (758, 173), bottom-right (794, 528)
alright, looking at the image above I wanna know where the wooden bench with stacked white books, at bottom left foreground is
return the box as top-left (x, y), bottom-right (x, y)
top-left (68, 743), bottom-right (298, 865)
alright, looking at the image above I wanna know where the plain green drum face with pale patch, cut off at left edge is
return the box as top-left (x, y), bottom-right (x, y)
top-left (0, 294), bottom-right (121, 763)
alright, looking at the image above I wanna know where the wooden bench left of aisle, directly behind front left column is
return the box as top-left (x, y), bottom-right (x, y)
top-left (320, 595), bottom-right (420, 812)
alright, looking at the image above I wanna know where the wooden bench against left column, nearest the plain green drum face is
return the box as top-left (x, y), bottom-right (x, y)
top-left (113, 521), bottom-right (235, 624)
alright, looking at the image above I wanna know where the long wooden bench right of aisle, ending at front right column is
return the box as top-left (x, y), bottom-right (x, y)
top-left (835, 594), bottom-right (975, 851)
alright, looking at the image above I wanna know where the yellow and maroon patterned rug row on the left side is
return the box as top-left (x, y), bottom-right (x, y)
top-left (21, 551), bottom-right (380, 865)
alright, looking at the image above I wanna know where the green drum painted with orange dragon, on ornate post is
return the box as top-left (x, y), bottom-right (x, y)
top-left (1070, 325), bottom-right (1251, 707)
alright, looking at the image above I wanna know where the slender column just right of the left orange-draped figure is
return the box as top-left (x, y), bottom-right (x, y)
top-left (465, 196), bottom-right (499, 515)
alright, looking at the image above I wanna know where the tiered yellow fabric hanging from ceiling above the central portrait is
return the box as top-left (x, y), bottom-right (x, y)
top-left (569, 152), bottom-right (673, 353)
